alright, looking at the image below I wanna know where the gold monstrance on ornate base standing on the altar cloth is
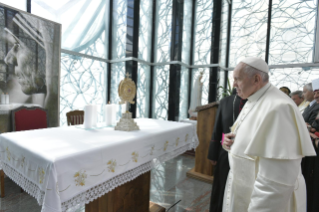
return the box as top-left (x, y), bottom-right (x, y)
top-left (114, 73), bottom-right (140, 131)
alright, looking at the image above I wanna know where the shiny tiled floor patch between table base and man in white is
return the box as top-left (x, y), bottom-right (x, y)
top-left (151, 155), bottom-right (212, 212)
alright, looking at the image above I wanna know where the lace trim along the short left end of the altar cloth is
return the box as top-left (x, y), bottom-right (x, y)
top-left (1, 162), bottom-right (44, 205)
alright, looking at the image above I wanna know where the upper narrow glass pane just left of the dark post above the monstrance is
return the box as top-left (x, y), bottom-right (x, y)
top-left (112, 0), bottom-right (127, 59)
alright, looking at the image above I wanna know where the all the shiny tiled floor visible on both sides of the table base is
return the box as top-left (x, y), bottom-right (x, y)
top-left (0, 155), bottom-right (212, 212)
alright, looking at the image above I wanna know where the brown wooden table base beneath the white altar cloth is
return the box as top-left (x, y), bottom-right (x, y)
top-left (85, 172), bottom-right (165, 212)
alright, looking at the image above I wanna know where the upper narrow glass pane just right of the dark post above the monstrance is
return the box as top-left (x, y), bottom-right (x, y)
top-left (138, 0), bottom-right (153, 62)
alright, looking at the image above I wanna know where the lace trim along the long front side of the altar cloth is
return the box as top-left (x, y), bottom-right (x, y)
top-left (62, 142), bottom-right (197, 212)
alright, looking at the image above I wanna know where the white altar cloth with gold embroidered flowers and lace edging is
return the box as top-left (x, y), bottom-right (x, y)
top-left (0, 119), bottom-right (198, 212)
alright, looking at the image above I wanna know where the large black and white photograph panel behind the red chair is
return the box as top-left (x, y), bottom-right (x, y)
top-left (0, 4), bottom-right (61, 127)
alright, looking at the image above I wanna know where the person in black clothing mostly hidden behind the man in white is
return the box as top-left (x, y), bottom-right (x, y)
top-left (208, 91), bottom-right (246, 212)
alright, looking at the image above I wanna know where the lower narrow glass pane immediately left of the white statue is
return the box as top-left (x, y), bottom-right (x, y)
top-left (179, 66), bottom-right (189, 120)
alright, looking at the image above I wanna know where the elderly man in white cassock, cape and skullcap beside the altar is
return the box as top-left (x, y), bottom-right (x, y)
top-left (223, 58), bottom-right (316, 212)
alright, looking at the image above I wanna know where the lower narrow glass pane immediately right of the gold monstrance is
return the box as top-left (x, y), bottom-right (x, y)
top-left (136, 63), bottom-right (151, 118)
